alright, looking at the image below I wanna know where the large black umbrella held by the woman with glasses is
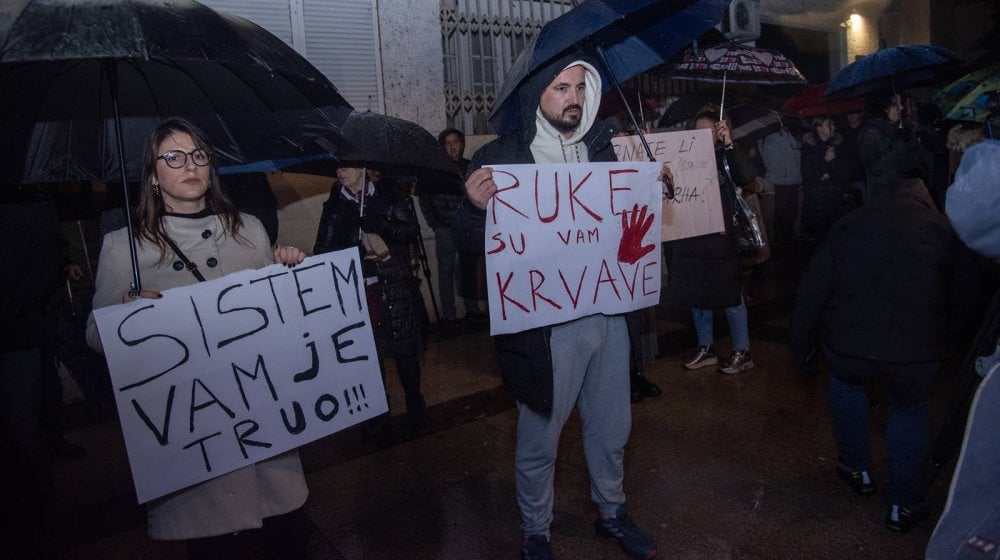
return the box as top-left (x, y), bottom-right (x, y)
top-left (0, 0), bottom-right (350, 289)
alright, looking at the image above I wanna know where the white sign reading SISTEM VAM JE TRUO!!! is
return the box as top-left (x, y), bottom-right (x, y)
top-left (94, 250), bottom-right (388, 503)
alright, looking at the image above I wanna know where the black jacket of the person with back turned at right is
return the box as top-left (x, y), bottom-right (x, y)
top-left (791, 179), bottom-right (978, 363)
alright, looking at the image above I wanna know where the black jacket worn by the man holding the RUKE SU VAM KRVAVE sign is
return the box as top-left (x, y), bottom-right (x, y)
top-left (452, 54), bottom-right (616, 415)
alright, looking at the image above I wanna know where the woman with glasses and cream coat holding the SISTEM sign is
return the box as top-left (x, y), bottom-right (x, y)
top-left (87, 118), bottom-right (308, 558)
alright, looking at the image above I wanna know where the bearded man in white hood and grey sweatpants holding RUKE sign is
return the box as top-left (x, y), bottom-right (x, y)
top-left (453, 53), bottom-right (656, 560)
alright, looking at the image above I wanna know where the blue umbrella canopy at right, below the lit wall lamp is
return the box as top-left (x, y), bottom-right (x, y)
top-left (826, 45), bottom-right (962, 96)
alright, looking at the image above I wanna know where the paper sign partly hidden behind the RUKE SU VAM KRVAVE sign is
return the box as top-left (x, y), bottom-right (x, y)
top-left (612, 129), bottom-right (725, 241)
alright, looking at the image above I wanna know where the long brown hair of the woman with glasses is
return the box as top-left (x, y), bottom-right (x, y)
top-left (133, 117), bottom-right (243, 259)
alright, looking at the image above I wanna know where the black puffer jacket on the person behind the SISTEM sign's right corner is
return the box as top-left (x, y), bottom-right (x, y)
top-left (313, 179), bottom-right (425, 340)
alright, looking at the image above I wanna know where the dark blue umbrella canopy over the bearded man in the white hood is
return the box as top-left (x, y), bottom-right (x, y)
top-left (490, 0), bottom-right (729, 134)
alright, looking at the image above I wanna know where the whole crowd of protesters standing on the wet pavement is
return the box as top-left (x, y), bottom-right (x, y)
top-left (0, 58), bottom-right (996, 560)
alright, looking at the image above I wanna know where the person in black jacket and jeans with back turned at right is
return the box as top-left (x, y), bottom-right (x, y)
top-left (790, 179), bottom-right (978, 531)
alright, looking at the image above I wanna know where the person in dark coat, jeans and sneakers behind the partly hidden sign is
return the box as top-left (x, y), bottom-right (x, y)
top-left (667, 110), bottom-right (757, 373)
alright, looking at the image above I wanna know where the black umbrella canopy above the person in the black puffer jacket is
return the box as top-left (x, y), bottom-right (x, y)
top-left (284, 111), bottom-right (461, 184)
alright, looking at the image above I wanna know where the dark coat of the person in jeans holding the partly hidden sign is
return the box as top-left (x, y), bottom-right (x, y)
top-left (664, 142), bottom-right (757, 309)
